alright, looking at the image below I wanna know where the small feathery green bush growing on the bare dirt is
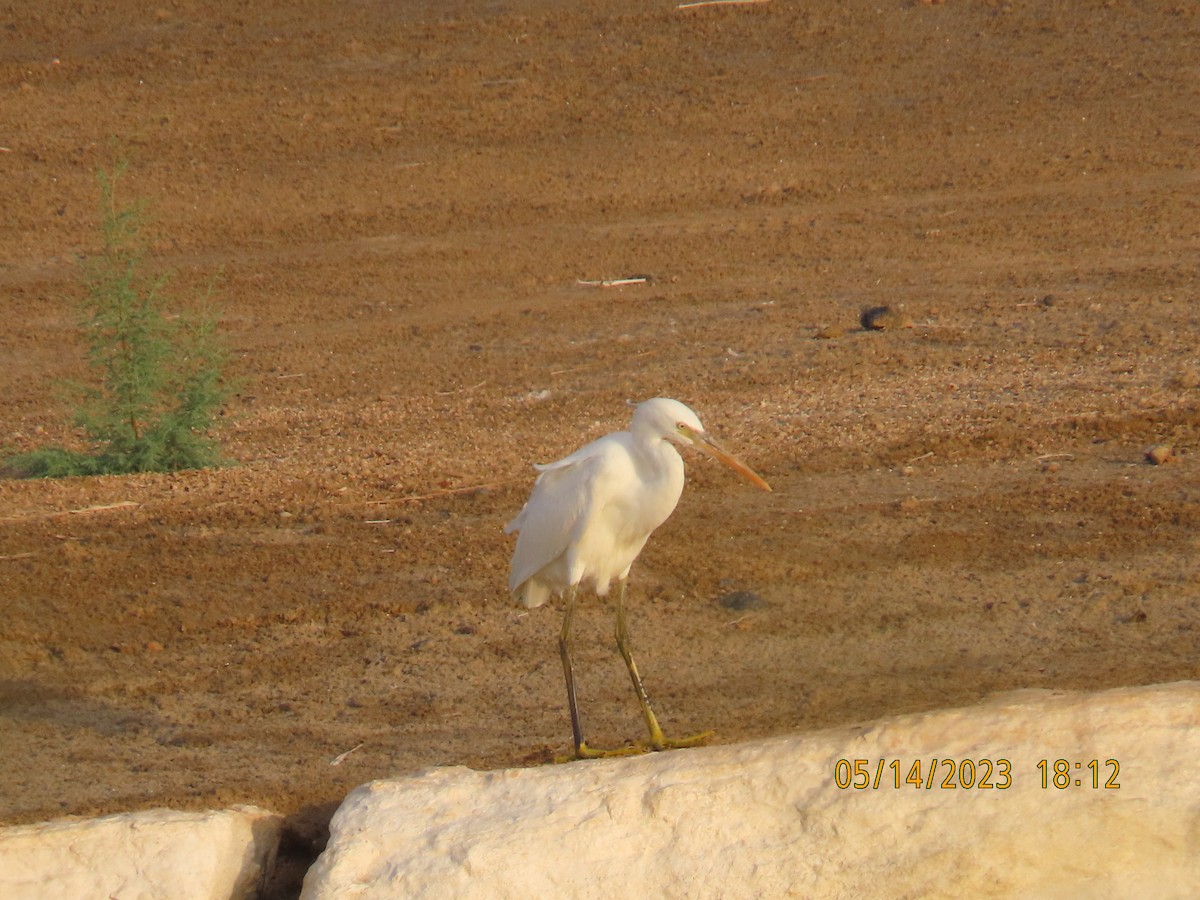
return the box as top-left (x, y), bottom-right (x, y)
top-left (5, 162), bottom-right (228, 478)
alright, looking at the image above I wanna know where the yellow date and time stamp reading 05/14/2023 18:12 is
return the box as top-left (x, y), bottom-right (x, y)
top-left (833, 757), bottom-right (1121, 791)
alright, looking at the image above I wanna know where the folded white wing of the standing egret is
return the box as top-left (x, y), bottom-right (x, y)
top-left (504, 438), bottom-right (619, 600)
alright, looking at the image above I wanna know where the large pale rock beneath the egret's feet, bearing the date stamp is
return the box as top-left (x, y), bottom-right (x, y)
top-left (302, 682), bottom-right (1200, 900)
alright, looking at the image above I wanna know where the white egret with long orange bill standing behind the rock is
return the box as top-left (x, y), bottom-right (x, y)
top-left (504, 397), bottom-right (770, 757)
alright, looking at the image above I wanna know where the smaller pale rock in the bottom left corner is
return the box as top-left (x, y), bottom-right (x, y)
top-left (0, 806), bottom-right (282, 900)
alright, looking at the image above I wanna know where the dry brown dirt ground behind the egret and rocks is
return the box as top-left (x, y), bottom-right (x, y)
top-left (0, 0), bottom-right (1200, 890)
